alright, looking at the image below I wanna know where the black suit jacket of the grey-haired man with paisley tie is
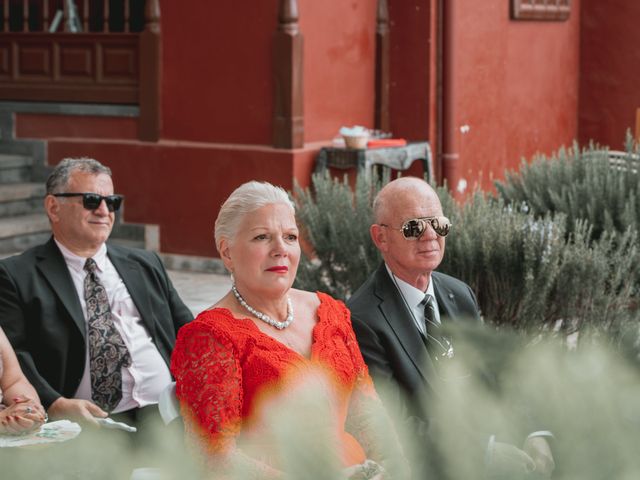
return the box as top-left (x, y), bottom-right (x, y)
top-left (0, 237), bottom-right (193, 408)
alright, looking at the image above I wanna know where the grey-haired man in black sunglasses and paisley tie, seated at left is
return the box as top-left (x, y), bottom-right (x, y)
top-left (0, 158), bottom-right (193, 436)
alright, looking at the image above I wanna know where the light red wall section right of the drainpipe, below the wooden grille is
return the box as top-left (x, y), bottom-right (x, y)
top-left (443, 0), bottom-right (580, 195)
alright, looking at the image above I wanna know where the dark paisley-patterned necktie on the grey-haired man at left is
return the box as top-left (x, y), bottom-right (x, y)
top-left (84, 258), bottom-right (131, 412)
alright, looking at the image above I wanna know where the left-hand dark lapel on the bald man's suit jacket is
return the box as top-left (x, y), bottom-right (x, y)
top-left (375, 263), bottom-right (438, 388)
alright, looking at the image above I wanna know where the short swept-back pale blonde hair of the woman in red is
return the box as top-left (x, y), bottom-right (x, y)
top-left (214, 181), bottom-right (295, 251)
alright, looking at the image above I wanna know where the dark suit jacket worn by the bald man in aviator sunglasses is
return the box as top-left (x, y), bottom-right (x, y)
top-left (347, 263), bottom-right (480, 422)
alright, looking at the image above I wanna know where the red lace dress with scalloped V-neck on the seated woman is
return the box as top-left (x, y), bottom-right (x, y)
top-left (171, 293), bottom-right (388, 476)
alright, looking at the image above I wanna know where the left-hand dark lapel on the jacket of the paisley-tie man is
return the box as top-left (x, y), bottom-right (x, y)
top-left (36, 237), bottom-right (87, 339)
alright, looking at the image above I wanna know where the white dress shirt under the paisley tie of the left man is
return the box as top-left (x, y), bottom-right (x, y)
top-left (56, 241), bottom-right (171, 413)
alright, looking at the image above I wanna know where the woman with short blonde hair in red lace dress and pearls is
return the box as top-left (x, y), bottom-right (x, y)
top-left (171, 182), bottom-right (404, 479)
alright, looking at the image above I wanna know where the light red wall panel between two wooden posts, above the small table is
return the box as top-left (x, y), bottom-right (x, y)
top-left (298, 0), bottom-right (376, 142)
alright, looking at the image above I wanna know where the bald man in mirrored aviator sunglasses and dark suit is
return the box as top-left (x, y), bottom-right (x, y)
top-left (347, 177), bottom-right (553, 479)
